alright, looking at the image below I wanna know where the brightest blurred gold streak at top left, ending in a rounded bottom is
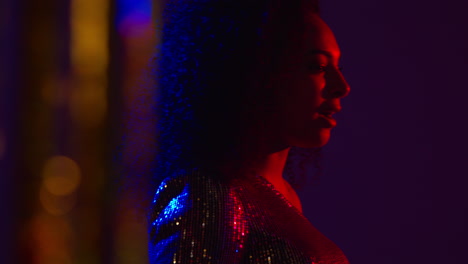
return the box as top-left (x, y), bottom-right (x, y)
top-left (70, 0), bottom-right (109, 128)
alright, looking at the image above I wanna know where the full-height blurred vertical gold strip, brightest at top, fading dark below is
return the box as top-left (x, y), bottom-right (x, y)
top-left (68, 0), bottom-right (110, 264)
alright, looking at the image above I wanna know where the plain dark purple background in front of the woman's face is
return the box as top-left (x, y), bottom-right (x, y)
top-left (300, 0), bottom-right (468, 264)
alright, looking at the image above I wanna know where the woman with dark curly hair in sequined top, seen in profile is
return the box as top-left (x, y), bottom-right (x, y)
top-left (149, 0), bottom-right (349, 264)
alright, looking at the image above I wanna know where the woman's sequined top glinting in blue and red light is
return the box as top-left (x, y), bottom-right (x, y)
top-left (149, 170), bottom-right (349, 264)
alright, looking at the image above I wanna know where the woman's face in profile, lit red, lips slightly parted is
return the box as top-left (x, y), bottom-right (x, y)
top-left (273, 14), bottom-right (349, 148)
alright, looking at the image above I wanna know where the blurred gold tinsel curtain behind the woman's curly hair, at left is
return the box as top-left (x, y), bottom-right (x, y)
top-left (0, 0), bottom-right (157, 264)
